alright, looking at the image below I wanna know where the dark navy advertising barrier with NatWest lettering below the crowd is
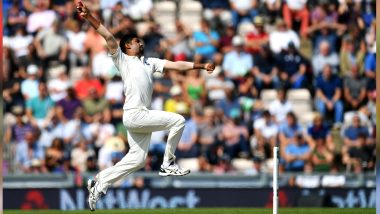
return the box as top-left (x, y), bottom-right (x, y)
top-left (4, 188), bottom-right (376, 210)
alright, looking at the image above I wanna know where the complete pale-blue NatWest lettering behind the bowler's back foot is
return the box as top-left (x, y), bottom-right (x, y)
top-left (60, 189), bottom-right (200, 210)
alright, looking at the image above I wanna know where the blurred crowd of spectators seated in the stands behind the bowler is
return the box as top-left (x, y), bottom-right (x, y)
top-left (2, 0), bottom-right (376, 186)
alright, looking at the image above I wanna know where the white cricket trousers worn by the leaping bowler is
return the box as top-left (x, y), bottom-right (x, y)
top-left (96, 107), bottom-right (185, 193)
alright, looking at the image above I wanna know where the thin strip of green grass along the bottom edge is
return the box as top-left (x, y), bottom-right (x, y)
top-left (4, 208), bottom-right (375, 214)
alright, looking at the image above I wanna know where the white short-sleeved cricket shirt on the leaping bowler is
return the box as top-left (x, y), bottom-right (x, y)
top-left (110, 48), bottom-right (166, 110)
